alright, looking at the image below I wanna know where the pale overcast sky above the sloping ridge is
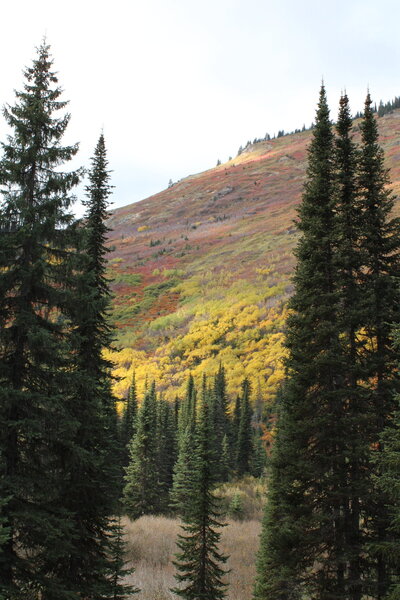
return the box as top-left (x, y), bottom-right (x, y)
top-left (0, 0), bottom-right (400, 214)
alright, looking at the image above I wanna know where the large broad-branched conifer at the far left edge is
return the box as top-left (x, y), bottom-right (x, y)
top-left (0, 43), bottom-right (81, 600)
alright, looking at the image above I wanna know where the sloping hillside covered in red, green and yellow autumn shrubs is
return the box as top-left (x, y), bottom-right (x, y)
top-left (104, 110), bottom-right (400, 400)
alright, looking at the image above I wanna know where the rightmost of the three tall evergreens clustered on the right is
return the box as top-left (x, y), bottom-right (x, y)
top-left (358, 94), bottom-right (400, 599)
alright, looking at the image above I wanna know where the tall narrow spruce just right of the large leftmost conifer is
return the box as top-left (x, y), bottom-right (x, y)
top-left (58, 135), bottom-right (128, 600)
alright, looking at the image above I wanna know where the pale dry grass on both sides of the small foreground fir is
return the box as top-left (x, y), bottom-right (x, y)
top-left (124, 516), bottom-right (261, 600)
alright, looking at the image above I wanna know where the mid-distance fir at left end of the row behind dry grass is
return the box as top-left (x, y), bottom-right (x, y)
top-left (123, 385), bottom-right (159, 519)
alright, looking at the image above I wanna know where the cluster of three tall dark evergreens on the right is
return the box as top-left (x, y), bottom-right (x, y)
top-left (254, 88), bottom-right (400, 600)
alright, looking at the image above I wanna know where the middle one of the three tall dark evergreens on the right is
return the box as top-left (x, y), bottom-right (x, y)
top-left (335, 94), bottom-right (371, 600)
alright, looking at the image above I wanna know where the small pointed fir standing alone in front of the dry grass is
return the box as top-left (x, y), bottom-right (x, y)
top-left (172, 386), bottom-right (227, 600)
